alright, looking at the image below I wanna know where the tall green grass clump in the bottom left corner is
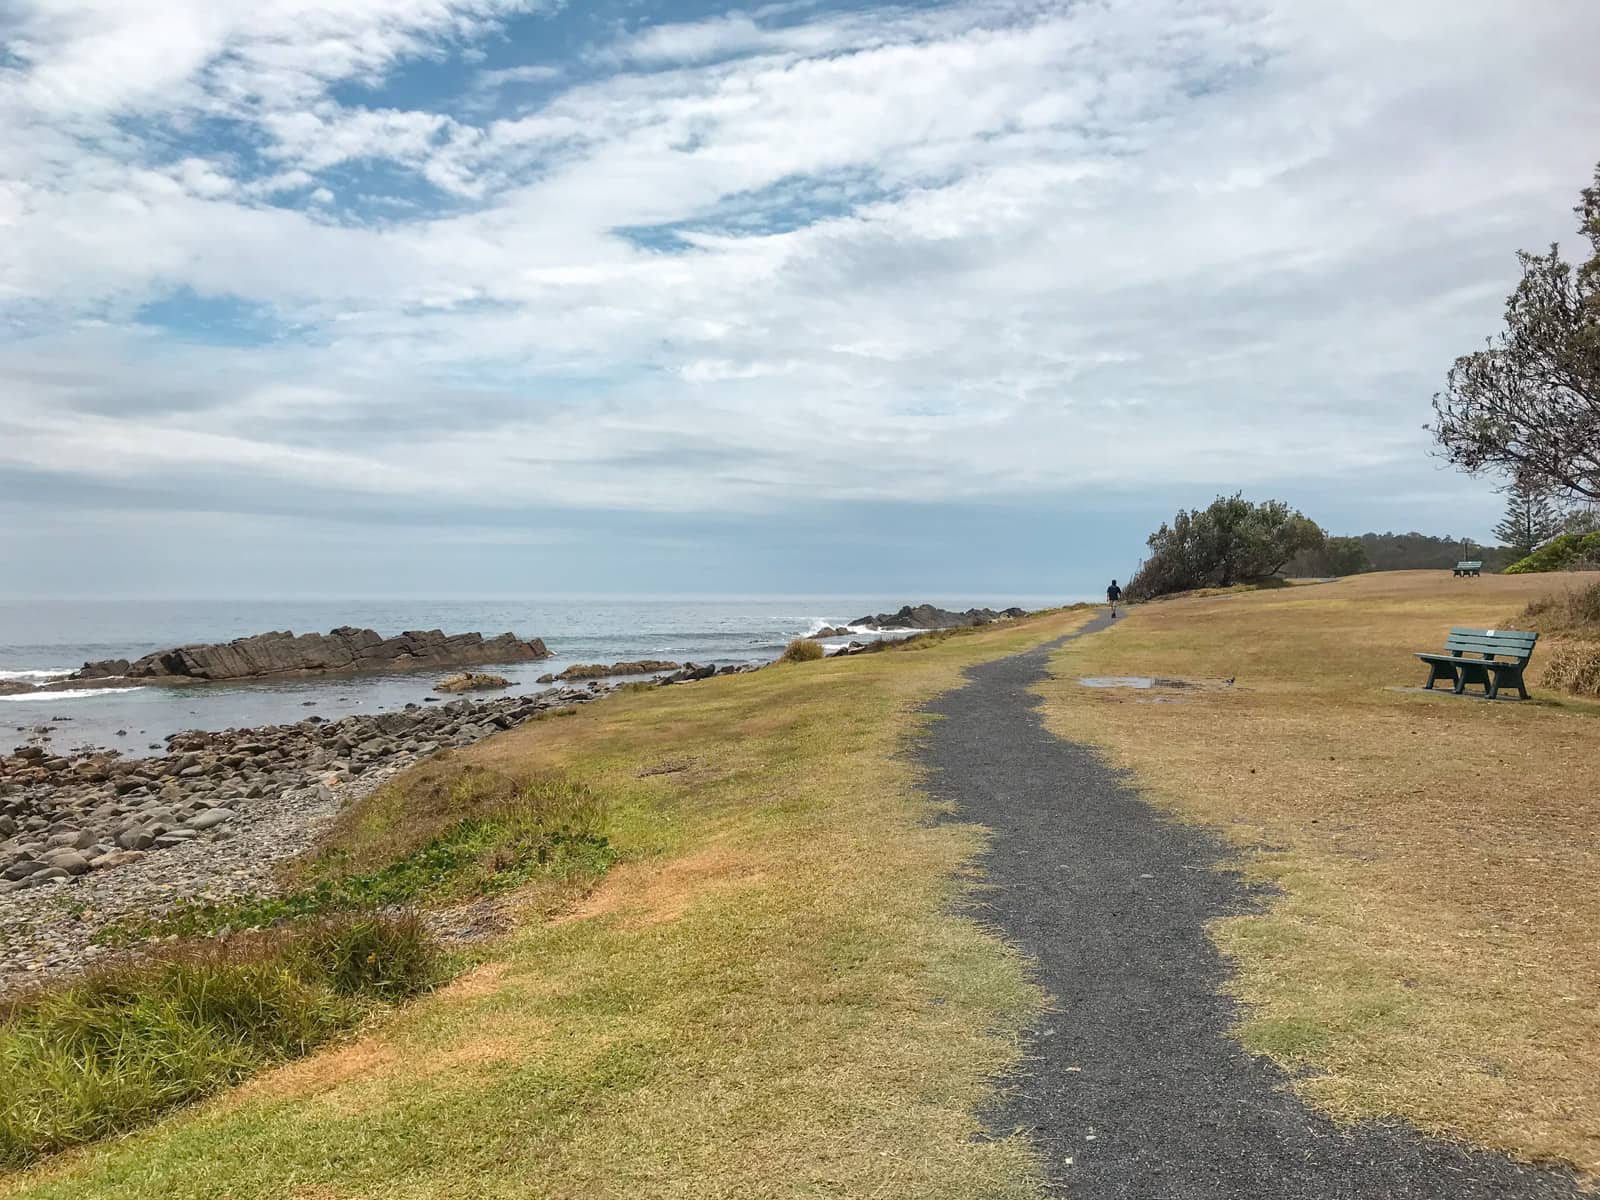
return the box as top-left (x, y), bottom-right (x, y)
top-left (0, 917), bottom-right (440, 1166)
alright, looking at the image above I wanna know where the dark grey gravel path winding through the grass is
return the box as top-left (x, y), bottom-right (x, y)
top-left (922, 618), bottom-right (1579, 1200)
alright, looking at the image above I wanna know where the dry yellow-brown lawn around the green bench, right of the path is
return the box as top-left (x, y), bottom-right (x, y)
top-left (1045, 573), bottom-right (1600, 1173)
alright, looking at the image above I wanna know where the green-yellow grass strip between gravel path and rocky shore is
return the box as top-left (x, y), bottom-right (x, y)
top-left (0, 614), bottom-right (1082, 1200)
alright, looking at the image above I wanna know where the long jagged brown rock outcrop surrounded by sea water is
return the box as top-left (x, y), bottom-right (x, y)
top-left (65, 626), bottom-right (550, 688)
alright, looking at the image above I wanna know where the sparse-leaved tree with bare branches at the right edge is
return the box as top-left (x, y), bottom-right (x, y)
top-left (1429, 166), bottom-right (1600, 501)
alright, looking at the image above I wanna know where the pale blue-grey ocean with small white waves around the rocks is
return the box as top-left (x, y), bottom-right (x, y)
top-left (0, 595), bottom-right (1085, 755)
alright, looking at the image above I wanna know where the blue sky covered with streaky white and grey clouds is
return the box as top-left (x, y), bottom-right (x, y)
top-left (0, 0), bottom-right (1600, 600)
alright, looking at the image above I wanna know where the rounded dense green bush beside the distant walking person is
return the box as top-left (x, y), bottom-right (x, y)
top-left (1128, 493), bottom-right (1325, 600)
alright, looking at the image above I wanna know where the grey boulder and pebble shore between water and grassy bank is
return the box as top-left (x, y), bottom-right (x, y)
top-left (0, 683), bottom-right (605, 995)
